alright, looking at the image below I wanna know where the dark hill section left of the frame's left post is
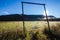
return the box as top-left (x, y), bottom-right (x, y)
top-left (0, 14), bottom-right (22, 21)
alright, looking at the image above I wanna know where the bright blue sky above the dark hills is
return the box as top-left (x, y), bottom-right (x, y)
top-left (0, 0), bottom-right (60, 17)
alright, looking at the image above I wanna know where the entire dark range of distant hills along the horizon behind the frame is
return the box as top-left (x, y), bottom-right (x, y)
top-left (0, 14), bottom-right (60, 21)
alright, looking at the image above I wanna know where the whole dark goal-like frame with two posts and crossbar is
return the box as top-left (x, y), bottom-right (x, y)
top-left (21, 2), bottom-right (50, 38)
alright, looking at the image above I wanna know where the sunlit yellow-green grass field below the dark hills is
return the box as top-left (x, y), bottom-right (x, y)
top-left (0, 21), bottom-right (60, 40)
